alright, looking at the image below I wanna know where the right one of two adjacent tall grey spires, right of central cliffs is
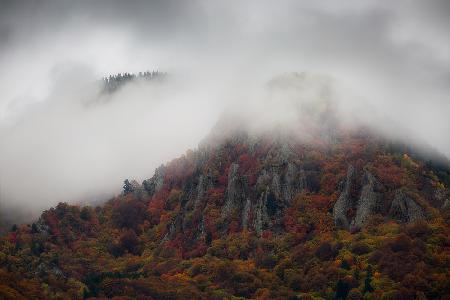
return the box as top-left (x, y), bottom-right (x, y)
top-left (352, 171), bottom-right (380, 229)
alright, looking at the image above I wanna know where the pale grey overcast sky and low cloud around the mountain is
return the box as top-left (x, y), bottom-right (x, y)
top-left (0, 0), bottom-right (450, 214)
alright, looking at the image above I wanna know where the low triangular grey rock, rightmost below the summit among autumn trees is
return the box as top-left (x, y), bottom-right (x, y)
top-left (389, 190), bottom-right (425, 222)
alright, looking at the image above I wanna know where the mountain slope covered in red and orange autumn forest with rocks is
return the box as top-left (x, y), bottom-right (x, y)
top-left (0, 75), bottom-right (450, 299)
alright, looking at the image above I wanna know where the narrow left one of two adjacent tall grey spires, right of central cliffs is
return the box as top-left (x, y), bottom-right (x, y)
top-left (333, 165), bottom-right (355, 229)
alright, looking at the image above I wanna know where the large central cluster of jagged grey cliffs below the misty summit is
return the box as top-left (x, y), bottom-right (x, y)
top-left (214, 141), bottom-right (308, 234)
